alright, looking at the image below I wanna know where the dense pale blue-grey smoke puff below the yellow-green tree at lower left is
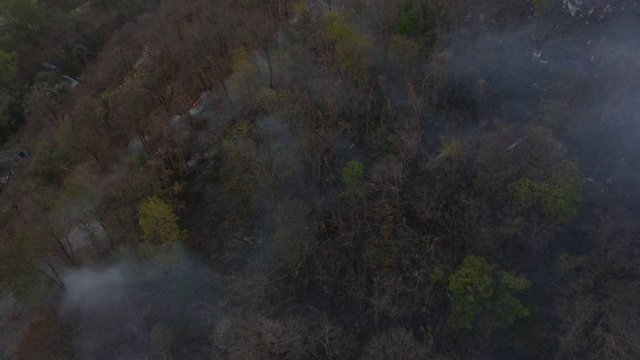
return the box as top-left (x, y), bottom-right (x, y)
top-left (61, 259), bottom-right (223, 359)
